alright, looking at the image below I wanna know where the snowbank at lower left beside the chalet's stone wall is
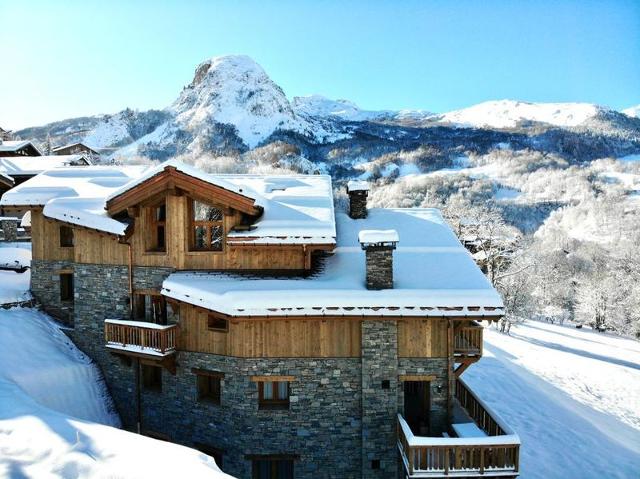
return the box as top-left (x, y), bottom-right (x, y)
top-left (0, 244), bottom-right (230, 479)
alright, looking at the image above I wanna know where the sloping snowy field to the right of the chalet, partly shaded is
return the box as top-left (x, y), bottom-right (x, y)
top-left (463, 321), bottom-right (640, 479)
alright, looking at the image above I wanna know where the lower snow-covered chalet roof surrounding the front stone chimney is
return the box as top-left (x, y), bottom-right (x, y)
top-left (162, 209), bottom-right (503, 317)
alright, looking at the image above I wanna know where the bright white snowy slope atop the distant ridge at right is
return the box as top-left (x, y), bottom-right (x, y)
top-left (439, 100), bottom-right (607, 128)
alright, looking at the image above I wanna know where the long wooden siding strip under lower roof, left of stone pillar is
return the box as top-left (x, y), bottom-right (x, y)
top-left (178, 303), bottom-right (361, 358)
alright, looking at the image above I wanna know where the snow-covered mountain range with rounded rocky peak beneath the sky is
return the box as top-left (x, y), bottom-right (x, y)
top-left (17, 55), bottom-right (640, 164)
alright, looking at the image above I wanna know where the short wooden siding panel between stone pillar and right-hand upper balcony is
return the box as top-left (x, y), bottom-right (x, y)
top-left (398, 319), bottom-right (447, 358)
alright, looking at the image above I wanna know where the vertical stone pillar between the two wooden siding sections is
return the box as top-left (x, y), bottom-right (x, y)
top-left (361, 320), bottom-right (398, 478)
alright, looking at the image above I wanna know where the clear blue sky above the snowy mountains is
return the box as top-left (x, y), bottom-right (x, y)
top-left (0, 0), bottom-right (640, 129)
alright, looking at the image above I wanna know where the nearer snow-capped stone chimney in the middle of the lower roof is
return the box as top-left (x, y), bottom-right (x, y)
top-left (358, 230), bottom-right (400, 289)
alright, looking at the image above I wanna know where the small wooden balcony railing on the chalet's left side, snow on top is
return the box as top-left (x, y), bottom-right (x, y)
top-left (104, 319), bottom-right (177, 356)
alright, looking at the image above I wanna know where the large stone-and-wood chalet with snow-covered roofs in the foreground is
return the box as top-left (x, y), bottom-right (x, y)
top-left (0, 161), bottom-right (520, 478)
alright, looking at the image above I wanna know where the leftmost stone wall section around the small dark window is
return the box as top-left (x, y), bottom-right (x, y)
top-left (31, 259), bottom-right (78, 326)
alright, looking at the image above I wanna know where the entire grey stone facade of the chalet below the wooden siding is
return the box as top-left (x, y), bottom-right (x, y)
top-left (32, 261), bottom-right (447, 479)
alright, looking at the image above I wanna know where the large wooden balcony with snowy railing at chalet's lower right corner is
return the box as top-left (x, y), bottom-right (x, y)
top-left (398, 379), bottom-right (520, 478)
